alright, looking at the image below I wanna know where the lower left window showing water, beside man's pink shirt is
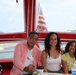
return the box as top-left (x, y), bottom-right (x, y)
top-left (0, 41), bottom-right (20, 60)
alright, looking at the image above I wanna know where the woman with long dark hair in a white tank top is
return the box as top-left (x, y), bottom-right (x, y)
top-left (41, 32), bottom-right (61, 73)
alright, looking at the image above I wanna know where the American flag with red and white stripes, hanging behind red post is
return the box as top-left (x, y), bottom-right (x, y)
top-left (36, 8), bottom-right (48, 32)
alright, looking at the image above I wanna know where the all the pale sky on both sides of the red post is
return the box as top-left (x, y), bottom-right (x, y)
top-left (0, 0), bottom-right (76, 33)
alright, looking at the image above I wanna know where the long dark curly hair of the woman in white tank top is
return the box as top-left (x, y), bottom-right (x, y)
top-left (44, 32), bottom-right (61, 56)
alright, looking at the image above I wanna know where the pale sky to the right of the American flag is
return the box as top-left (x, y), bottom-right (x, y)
top-left (40, 0), bottom-right (76, 32)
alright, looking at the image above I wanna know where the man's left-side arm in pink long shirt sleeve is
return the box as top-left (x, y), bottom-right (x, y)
top-left (13, 44), bottom-right (24, 70)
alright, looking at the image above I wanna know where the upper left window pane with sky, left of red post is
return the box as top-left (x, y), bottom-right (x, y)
top-left (0, 0), bottom-right (25, 34)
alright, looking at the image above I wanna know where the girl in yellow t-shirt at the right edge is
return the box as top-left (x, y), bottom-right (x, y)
top-left (62, 40), bottom-right (76, 74)
